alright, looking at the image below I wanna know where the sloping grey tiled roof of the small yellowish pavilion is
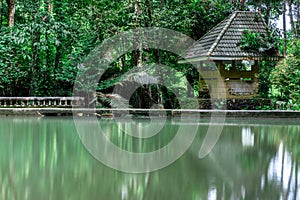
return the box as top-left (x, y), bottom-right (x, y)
top-left (185, 11), bottom-right (280, 61)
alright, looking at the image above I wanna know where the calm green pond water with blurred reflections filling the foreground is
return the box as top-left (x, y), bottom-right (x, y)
top-left (0, 117), bottom-right (300, 200)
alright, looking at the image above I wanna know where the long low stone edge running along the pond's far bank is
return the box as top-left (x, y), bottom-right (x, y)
top-left (0, 107), bottom-right (300, 119)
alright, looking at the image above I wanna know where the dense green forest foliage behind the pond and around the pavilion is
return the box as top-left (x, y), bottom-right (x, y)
top-left (0, 0), bottom-right (300, 109)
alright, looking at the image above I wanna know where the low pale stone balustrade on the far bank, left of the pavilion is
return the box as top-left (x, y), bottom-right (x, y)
top-left (0, 97), bottom-right (84, 107)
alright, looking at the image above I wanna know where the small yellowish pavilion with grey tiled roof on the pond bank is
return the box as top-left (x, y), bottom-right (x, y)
top-left (183, 11), bottom-right (280, 97)
